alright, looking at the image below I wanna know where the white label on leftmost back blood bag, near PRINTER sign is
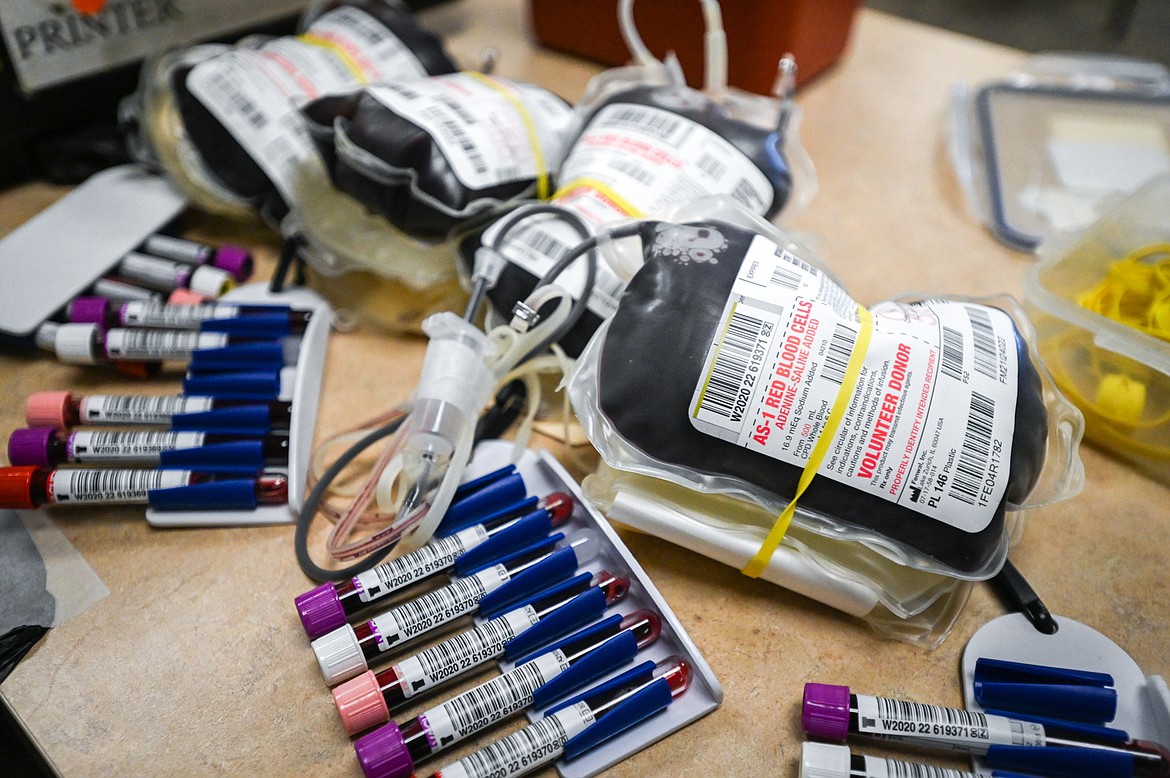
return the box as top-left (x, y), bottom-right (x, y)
top-left (187, 6), bottom-right (426, 202)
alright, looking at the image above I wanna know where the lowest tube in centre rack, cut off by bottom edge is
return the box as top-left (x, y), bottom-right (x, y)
top-left (431, 655), bottom-right (687, 778)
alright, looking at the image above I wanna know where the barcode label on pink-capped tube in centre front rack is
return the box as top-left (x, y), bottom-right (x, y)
top-left (397, 605), bottom-right (541, 697)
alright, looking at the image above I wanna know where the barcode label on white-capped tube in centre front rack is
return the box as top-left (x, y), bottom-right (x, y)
top-left (370, 565), bottom-right (511, 652)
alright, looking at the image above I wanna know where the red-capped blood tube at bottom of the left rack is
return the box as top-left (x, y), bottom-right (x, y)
top-left (0, 467), bottom-right (288, 510)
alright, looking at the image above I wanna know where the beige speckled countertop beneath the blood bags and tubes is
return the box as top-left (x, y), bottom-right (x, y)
top-left (0, 0), bottom-right (1170, 776)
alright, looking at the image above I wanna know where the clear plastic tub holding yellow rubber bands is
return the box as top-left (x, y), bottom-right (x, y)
top-left (1024, 177), bottom-right (1170, 482)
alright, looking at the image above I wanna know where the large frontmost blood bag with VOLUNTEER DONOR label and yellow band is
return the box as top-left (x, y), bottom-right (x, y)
top-left (571, 203), bottom-right (1082, 580)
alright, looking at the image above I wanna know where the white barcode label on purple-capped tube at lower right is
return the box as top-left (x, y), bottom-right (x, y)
top-left (855, 694), bottom-right (1045, 753)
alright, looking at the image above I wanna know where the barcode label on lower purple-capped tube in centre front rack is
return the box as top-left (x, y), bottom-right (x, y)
top-left (419, 649), bottom-right (570, 751)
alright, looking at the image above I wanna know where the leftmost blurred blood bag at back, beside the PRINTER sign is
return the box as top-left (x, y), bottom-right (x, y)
top-left (123, 0), bottom-right (456, 223)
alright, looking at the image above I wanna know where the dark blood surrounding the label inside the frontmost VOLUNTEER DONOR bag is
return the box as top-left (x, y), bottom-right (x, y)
top-left (597, 222), bottom-right (1047, 573)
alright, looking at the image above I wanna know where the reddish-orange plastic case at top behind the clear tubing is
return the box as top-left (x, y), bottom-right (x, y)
top-left (530, 0), bottom-right (858, 95)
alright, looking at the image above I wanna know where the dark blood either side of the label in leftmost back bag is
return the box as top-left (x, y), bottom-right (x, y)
top-left (171, 0), bottom-right (456, 216)
